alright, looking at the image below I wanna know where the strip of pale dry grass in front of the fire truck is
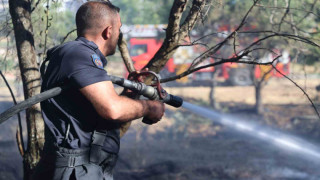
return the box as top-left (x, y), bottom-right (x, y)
top-left (166, 78), bottom-right (320, 105)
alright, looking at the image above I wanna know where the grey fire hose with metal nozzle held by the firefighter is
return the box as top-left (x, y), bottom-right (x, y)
top-left (0, 71), bottom-right (183, 124)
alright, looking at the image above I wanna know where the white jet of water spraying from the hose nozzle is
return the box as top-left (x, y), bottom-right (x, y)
top-left (182, 101), bottom-right (320, 162)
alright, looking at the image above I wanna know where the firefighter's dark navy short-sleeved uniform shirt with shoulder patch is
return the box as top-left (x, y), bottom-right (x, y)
top-left (41, 37), bottom-right (120, 153)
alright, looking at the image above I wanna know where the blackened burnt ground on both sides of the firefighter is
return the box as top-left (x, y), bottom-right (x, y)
top-left (0, 79), bottom-right (320, 180)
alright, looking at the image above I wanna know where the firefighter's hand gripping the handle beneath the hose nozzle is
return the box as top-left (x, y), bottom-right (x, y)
top-left (142, 101), bottom-right (165, 125)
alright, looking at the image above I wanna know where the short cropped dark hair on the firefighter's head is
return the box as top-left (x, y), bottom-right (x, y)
top-left (76, 1), bottom-right (120, 36)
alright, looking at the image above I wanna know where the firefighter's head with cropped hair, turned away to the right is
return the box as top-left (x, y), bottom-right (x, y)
top-left (76, 1), bottom-right (121, 55)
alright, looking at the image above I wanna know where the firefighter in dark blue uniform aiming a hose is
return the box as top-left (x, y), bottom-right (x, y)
top-left (33, 1), bottom-right (164, 180)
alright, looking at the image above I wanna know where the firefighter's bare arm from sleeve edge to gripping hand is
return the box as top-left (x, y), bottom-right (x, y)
top-left (80, 81), bottom-right (164, 122)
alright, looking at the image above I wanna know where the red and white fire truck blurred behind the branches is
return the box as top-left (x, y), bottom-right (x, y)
top-left (122, 25), bottom-right (290, 86)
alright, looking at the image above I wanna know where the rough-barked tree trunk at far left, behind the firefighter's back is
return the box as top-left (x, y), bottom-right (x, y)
top-left (9, 0), bottom-right (44, 179)
